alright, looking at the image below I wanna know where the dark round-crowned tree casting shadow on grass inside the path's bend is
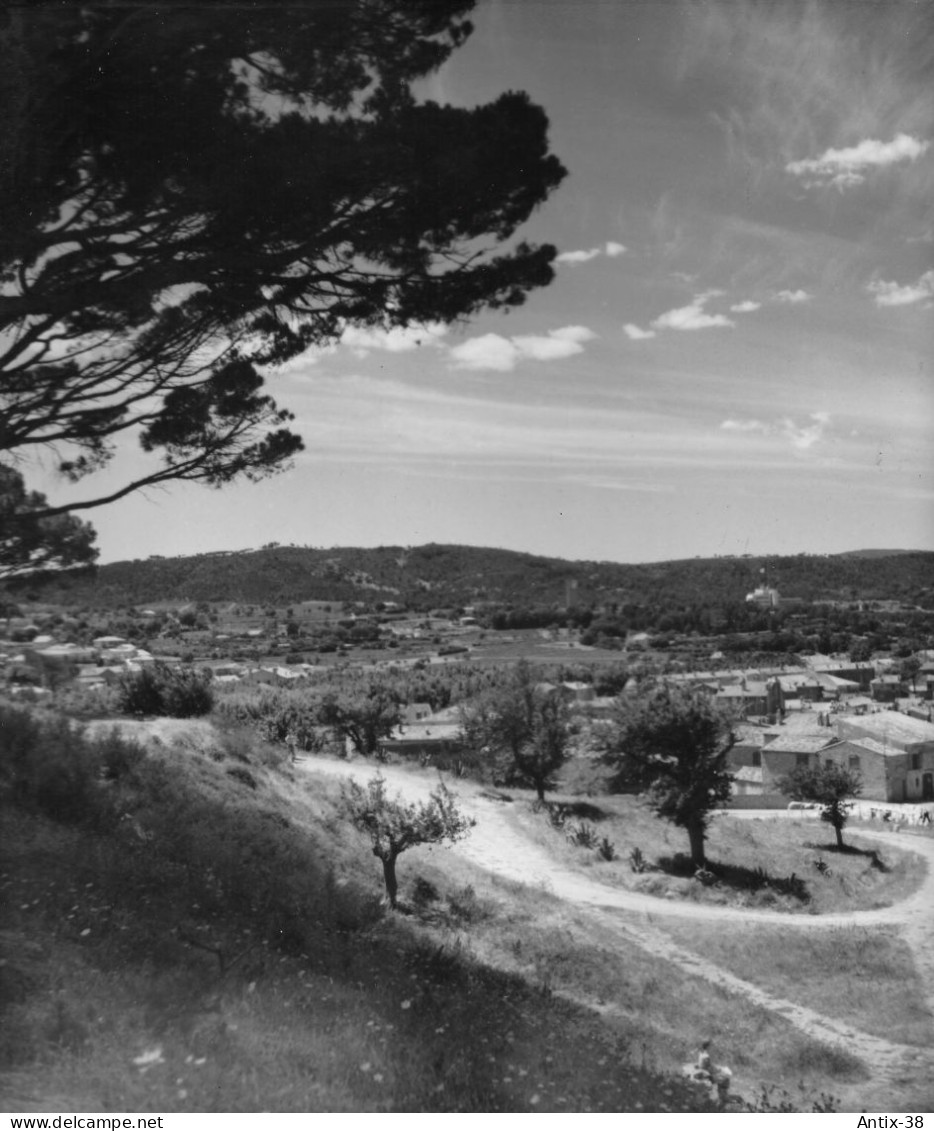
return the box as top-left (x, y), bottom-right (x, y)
top-left (603, 685), bottom-right (735, 867)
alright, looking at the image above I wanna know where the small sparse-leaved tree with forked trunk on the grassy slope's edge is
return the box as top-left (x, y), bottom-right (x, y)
top-left (344, 774), bottom-right (476, 907)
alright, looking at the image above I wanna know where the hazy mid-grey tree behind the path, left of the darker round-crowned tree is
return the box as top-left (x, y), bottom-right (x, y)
top-left (461, 661), bottom-right (569, 801)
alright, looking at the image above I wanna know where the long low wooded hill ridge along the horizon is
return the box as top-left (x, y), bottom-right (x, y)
top-left (10, 544), bottom-right (934, 608)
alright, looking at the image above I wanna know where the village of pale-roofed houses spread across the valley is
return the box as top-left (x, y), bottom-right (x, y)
top-left (0, 589), bottom-right (934, 820)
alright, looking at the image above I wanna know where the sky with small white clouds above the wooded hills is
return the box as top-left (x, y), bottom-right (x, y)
top-left (31, 0), bottom-right (934, 562)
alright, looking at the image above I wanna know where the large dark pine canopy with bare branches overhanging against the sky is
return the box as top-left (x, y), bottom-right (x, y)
top-left (0, 0), bottom-right (564, 513)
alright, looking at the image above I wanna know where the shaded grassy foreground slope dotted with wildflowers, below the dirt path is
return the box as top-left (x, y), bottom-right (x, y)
top-left (0, 708), bottom-right (895, 1112)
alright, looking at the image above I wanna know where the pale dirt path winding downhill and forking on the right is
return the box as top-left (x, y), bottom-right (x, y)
top-left (300, 758), bottom-right (934, 1094)
